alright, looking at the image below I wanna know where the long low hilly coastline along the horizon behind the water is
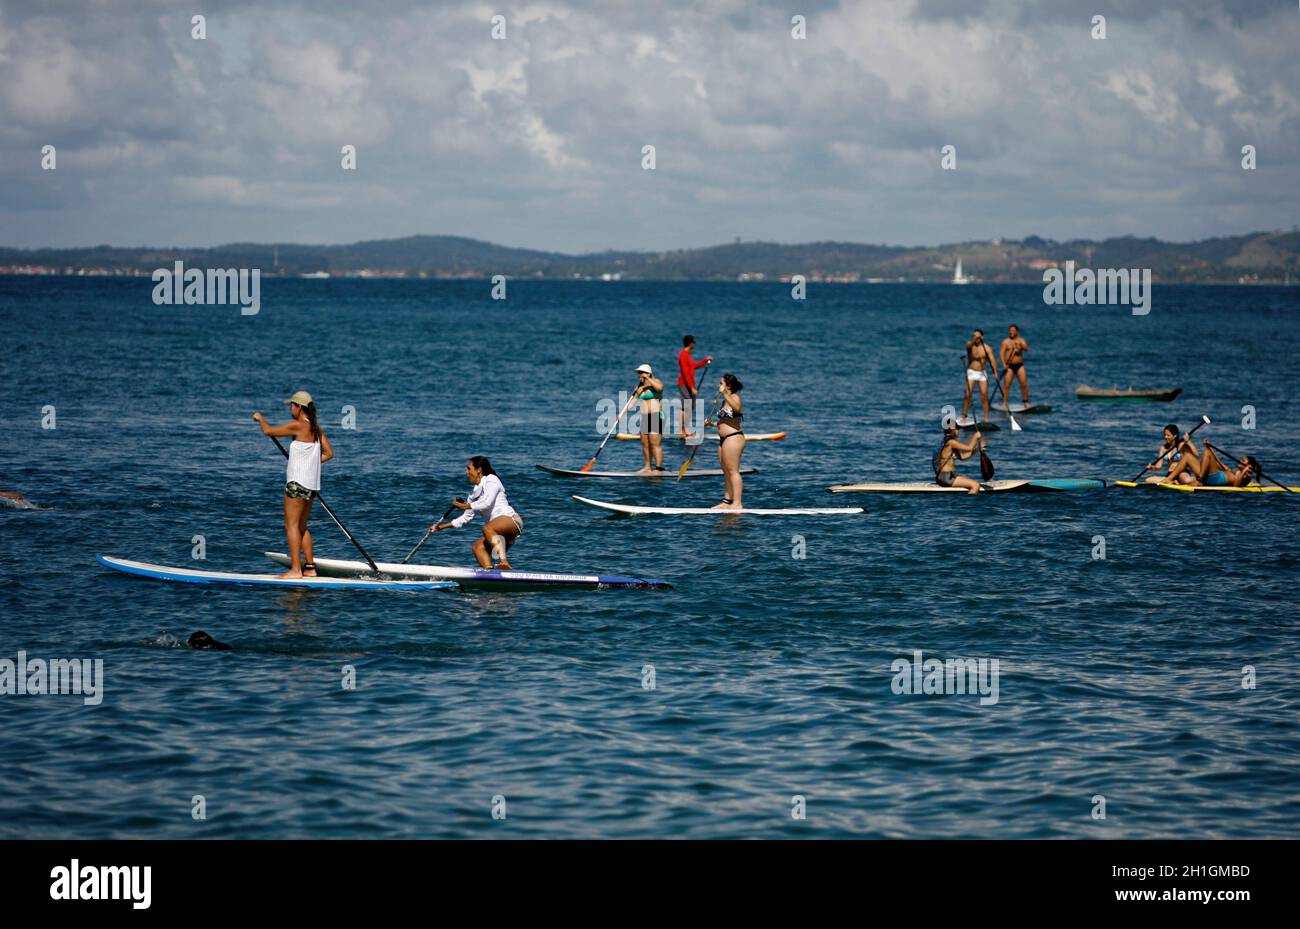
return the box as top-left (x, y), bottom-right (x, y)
top-left (0, 230), bottom-right (1300, 283)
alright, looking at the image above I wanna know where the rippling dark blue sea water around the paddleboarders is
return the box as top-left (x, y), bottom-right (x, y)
top-left (0, 278), bottom-right (1300, 838)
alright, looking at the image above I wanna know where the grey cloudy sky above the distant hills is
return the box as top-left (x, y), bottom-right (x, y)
top-left (0, 0), bottom-right (1300, 252)
